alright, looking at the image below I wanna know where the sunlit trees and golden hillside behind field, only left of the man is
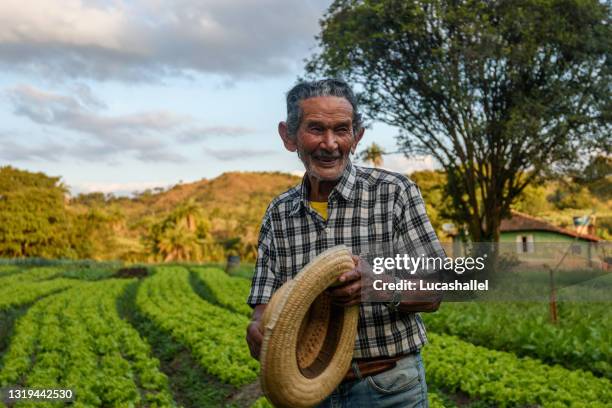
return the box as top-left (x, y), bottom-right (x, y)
top-left (0, 167), bottom-right (300, 262)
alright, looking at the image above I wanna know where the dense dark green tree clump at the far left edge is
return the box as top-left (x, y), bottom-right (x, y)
top-left (0, 166), bottom-right (76, 258)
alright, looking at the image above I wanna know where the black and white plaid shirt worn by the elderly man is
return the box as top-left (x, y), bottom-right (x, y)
top-left (247, 162), bottom-right (445, 358)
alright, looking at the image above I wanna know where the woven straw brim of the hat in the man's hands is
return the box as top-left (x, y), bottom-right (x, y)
top-left (260, 245), bottom-right (359, 408)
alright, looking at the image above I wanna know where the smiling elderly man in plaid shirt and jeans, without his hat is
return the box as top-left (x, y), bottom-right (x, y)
top-left (247, 79), bottom-right (444, 407)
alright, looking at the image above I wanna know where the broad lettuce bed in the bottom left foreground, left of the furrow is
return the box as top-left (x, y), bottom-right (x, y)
top-left (0, 280), bottom-right (175, 407)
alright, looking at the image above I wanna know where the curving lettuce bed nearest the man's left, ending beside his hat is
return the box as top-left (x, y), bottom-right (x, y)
top-left (136, 267), bottom-right (259, 386)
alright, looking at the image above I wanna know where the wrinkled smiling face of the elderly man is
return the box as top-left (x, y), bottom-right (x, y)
top-left (296, 96), bottom-right (361, 181)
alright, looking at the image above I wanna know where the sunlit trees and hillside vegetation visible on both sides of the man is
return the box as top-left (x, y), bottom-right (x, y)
top-left (0, 161), bottom-right (612, 262)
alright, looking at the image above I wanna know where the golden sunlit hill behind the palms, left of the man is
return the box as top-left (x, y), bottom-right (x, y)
top-left (69, 172), bottom-right (301, 261)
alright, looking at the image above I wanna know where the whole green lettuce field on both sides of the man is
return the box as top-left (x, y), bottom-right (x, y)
top-left (0, 262), bottom-right (612, 408)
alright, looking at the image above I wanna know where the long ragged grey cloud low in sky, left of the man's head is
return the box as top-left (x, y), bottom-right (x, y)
top-left (7, 85), bottom-right (250, 162)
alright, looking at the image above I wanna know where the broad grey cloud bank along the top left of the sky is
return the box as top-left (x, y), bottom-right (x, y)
top-left (0, 0), bottom-right (330, 82)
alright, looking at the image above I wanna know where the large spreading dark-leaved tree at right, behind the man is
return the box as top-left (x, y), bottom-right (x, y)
top-left (306, 0), bottom-right (612, 241)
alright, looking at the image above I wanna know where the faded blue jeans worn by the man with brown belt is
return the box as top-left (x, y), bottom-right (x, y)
top-left (319, 353), bottom-right (429, 408)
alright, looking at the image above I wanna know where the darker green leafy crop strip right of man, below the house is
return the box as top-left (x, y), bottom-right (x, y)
top-left (424, 302), bottom-right (612, 378)
